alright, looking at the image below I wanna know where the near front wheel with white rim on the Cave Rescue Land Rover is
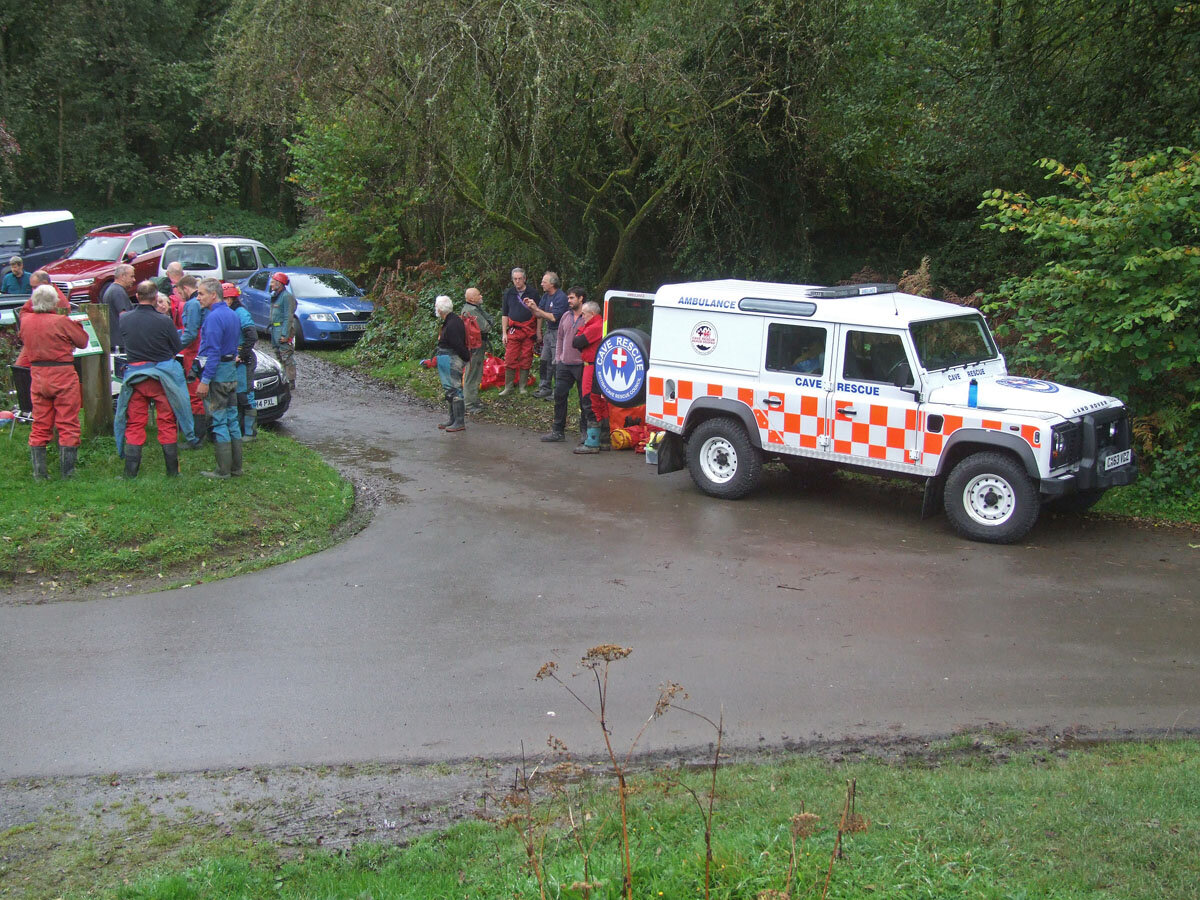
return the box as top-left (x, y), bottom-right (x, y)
top-left (944, 452), bottom-right (1042, 544)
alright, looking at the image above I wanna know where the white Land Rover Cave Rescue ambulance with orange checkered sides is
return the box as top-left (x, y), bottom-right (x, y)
top-left (596, 281), bottom-right (1138, 544)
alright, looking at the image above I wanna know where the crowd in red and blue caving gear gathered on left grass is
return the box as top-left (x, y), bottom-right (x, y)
top-left (17, 265), bottom-right (295, 479)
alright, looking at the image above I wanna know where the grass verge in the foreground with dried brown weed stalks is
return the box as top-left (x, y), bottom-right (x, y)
top-left (0, 740), bottom-right (1200, 900)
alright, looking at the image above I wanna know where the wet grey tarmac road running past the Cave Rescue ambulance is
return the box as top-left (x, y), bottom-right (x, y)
top-left (0, 356), bottom-right (1200, 776)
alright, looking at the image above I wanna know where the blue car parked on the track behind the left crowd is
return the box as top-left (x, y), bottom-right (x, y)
top-left (239, 265), bottom-right (374, 348)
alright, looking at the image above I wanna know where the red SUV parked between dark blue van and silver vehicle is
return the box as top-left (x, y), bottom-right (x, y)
top-left (46, 222), bottom-right (180, 304)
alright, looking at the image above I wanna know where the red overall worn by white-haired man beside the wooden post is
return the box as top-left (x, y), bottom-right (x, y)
top-left (20, 312), bottom-right (88, 446)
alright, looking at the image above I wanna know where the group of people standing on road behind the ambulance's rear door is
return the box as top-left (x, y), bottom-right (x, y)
top-left (434, 268), bottom-right (612, 454)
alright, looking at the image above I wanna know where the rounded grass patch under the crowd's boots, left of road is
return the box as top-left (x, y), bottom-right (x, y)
top-left (0, 428), bottom-right (354, 596)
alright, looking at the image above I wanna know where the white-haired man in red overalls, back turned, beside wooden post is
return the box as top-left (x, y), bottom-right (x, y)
top-left (20, 284), bottom-right (88, 481)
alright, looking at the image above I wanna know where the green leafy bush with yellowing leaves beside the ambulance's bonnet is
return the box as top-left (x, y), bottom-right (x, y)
top-left (980, 144), bottom-right (1200, 456)
